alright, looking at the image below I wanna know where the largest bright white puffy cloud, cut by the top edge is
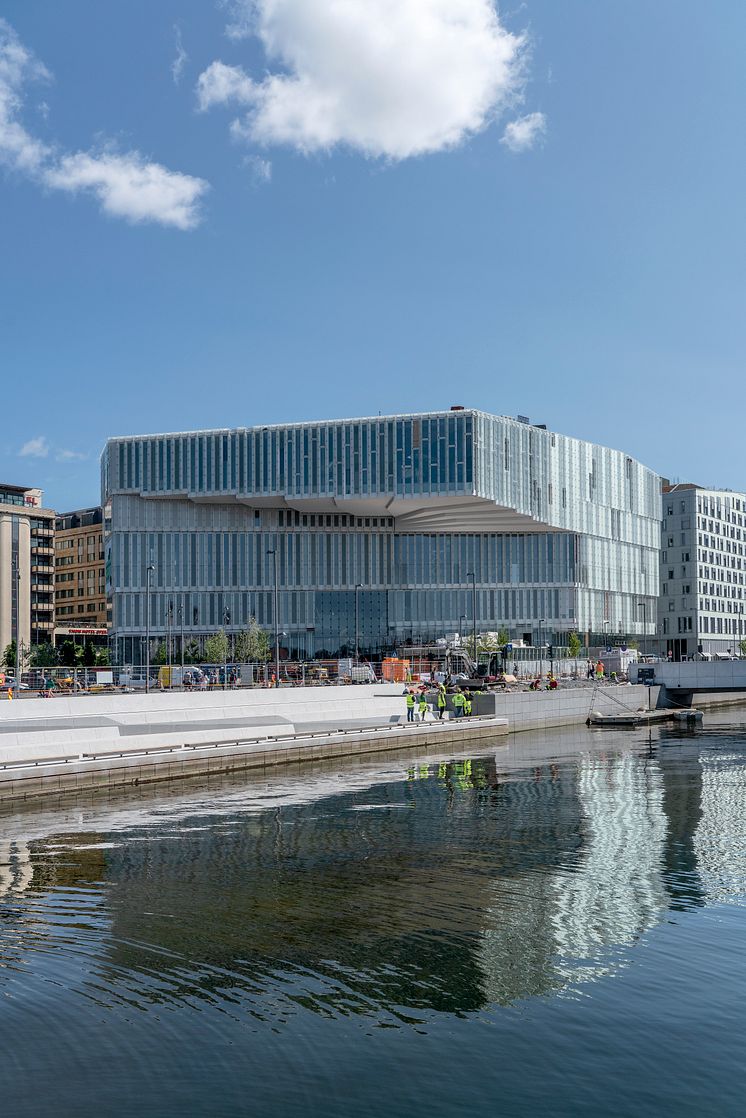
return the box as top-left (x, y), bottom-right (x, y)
top-left (197, 0), bottom-right (526, 160)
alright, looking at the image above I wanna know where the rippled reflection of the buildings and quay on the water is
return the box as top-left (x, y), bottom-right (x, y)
top-left (0, 715), bottom-right (746, 1026)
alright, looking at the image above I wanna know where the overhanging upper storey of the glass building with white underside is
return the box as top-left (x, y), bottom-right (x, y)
top-left (102, 408), bottom-right (661, 548)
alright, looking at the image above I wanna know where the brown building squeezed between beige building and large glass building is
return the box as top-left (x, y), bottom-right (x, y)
top-left (55, 508), bottom-right (107, 643)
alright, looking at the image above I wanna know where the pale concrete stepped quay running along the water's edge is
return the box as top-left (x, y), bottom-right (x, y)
top-left (0, 684), bottom-right (675, 799)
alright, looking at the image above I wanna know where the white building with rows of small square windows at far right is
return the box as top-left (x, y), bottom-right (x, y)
top-left (659, 484), bottom-right (746, 660)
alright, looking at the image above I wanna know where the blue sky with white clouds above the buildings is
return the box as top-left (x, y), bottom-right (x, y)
top-left (0, 0), bottom-right (746, 510)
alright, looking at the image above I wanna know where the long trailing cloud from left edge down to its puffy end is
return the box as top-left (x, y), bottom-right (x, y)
top-left (0, 19), bottom-right (209, 229)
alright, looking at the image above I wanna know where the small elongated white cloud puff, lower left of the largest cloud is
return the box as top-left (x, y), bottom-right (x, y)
top-left (45, 151), bottom-right (208, 229)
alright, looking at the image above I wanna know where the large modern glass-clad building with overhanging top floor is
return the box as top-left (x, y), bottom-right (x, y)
top-left (102, 408), bottom-right (661, 663)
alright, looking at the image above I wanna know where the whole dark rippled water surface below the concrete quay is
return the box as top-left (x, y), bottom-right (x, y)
top-left (0, 712), bottom-right (746, 1118)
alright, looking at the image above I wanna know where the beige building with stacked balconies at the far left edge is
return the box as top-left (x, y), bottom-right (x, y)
top-left (0, 482), bottom-right (55, 653)
